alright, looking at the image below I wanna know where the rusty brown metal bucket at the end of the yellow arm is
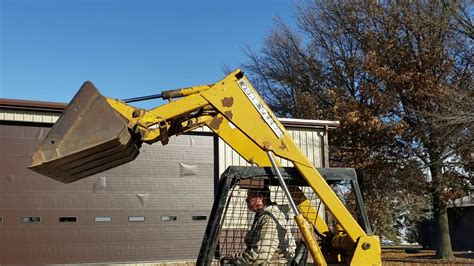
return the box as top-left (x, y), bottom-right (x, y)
top-left (28, 81), bottom-right (141, 183)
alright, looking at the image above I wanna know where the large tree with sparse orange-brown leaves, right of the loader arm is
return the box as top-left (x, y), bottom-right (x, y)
top-left (246, 0), bottom-right (474, 258)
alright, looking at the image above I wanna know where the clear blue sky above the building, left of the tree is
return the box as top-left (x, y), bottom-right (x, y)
top-left (0, 0), bottom-right (294, 107)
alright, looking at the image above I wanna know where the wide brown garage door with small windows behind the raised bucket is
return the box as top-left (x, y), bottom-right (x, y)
top-left (0, 124), bottom-right (216, 264)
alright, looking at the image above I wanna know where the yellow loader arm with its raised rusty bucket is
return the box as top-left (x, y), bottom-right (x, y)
top-left (30, 70), bottom-right (381, 265)
